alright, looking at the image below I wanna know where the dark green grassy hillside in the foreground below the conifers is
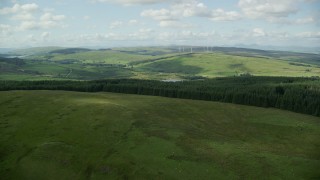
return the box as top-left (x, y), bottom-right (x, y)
top-left (0, 91), bottom-right (320, 179)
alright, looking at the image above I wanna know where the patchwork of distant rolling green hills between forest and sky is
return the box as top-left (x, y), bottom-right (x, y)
top-left (0, 47), bottom-right (320, 80)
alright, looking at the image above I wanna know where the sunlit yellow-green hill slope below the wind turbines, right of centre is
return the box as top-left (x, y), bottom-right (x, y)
top-left (140, 53), bottom-right (320, 77)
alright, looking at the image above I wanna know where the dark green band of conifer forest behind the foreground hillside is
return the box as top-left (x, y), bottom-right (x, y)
top-left (0, 77), bottom-right (320, 116)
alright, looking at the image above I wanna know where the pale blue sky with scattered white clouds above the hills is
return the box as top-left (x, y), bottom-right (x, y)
top-left (0, 0), bottom-right (320, 48)
